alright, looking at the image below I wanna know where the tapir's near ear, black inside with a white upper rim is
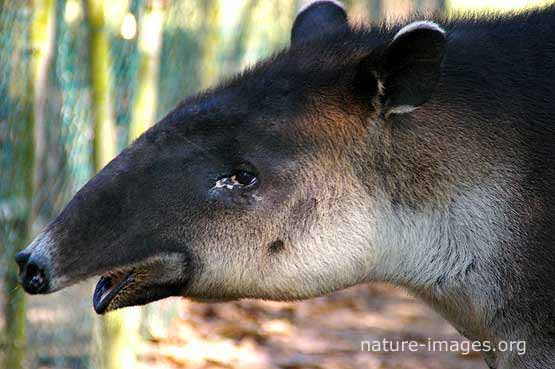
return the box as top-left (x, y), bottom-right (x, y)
top-left (365, 22), bottom-right (447, 115)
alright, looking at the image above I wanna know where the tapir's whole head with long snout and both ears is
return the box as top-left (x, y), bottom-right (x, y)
top-left (16, 1), bottom-right (445, 313)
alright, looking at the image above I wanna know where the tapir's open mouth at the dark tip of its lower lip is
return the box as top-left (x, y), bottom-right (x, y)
top-left (93, 269), bottom-right (135, 314)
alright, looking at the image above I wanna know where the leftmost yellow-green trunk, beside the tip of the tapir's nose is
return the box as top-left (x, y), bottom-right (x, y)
top-left (0, 0), bottom-right (56, 369)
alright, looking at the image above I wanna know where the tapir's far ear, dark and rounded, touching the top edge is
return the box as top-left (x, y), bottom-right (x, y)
top-left (291, 0), bottom-right (348, 45)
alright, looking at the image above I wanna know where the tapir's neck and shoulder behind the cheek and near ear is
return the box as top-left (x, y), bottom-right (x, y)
top-left (358, 19), bottom-right (555, 369)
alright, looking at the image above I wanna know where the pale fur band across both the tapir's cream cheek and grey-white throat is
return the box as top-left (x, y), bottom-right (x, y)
top-left (187, 171), bottom-right (509, 306)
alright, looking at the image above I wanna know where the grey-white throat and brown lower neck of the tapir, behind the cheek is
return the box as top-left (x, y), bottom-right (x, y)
top-left (364, 177), bottom-right (555, 369)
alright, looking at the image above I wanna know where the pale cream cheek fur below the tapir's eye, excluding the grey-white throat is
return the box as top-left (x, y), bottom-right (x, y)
top-left (185, 168), bottom-right (376, 300)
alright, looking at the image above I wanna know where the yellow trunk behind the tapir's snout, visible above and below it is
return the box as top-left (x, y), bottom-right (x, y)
top-left (87, 0), bottom-right (140, 369)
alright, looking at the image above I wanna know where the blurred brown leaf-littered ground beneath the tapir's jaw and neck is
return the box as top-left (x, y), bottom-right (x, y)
top-left (135, 284), bottom-right (486, 369)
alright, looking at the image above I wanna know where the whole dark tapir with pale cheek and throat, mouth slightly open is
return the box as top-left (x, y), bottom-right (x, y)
top-left (16, 1), bottom-right (555, 369)
